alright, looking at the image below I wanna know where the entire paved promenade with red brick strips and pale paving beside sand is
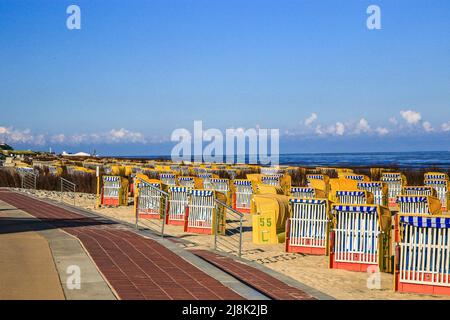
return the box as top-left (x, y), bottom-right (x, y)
top-left (0, 189), bottom-right (324, 300)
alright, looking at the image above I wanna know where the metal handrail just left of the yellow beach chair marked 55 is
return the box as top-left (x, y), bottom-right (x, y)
top-left (214, 199), bottom-right (244, 257)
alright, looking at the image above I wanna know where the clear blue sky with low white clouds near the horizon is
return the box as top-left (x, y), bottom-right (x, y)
top-left (0, 0), bottom-right (450, 155)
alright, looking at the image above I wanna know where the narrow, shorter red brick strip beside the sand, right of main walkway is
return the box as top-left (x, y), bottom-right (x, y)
top-left (190, 250), bottom-right (315, 300)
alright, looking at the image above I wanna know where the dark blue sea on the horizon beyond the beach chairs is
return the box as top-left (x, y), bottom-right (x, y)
top-left (120, 151), bottom-right (450, 169)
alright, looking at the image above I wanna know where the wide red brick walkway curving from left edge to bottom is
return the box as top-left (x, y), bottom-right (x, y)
top-left (0, 190), bottom-right (242, 300)
